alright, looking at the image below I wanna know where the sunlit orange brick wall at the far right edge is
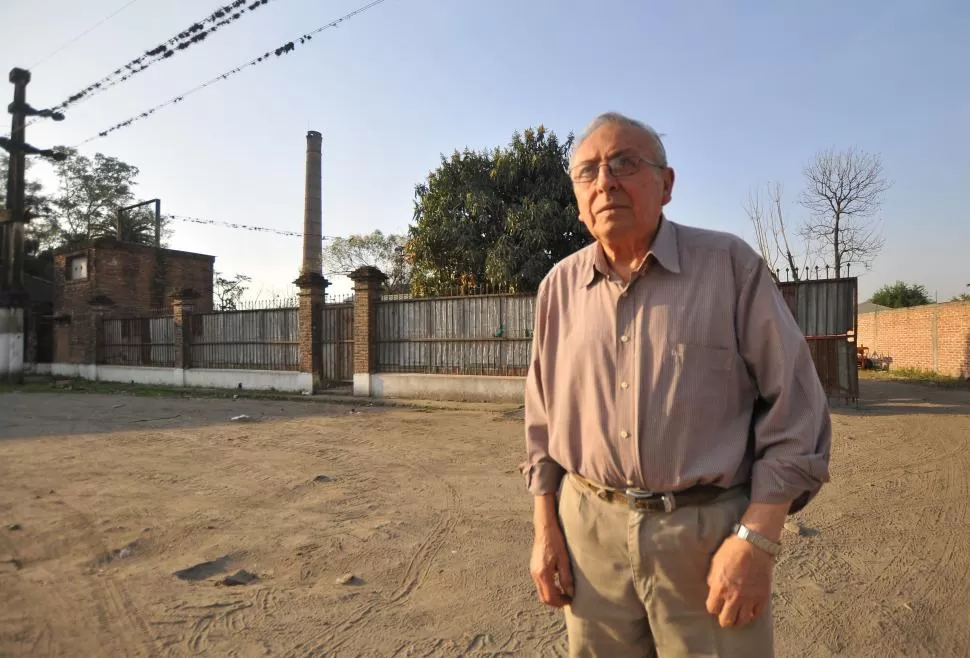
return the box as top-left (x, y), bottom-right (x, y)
top-left (859, 302), bottom-right (970, 377)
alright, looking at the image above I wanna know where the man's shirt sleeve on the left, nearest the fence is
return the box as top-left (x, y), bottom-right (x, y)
top-left (519, 281), bottom-right (565, 496)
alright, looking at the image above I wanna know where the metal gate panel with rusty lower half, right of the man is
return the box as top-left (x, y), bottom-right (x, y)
top-left (778, 277), bottom-right (859, 402)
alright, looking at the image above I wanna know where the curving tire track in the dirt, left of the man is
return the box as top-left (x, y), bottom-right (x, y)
top-left (284, 464), bottom-right (462, 657)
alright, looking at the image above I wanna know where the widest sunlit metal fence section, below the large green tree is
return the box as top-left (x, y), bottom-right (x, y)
top-left (374, 294), bottom-right (535, 375)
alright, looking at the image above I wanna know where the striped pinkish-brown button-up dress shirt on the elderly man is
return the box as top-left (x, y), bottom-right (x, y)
top-left (521, 218), bottom-right (831, 512)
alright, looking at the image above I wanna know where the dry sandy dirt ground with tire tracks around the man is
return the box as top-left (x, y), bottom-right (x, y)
top-left (0, 382), bottom-right (970, 658)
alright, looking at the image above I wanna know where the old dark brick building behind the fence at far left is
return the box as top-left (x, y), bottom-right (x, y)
top-left (53, 239), bottom-right (215, 363)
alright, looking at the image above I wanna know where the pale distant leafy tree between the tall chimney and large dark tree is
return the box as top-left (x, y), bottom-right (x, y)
top-left (323, 231), bottom-right (411, 292)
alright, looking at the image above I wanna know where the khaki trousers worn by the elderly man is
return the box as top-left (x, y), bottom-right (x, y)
top-left (559, 476), bottom-right (774, 658)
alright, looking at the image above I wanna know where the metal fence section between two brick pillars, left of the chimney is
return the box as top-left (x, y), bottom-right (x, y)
top-left (188, 308), bottom-right (300, 370)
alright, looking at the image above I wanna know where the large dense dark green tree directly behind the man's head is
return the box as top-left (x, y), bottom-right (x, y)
top-left (405, 126), bottom-right (590, 295)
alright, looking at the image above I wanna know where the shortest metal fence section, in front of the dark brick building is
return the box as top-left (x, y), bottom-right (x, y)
top-left (97, 316), bottom-right (175, 368)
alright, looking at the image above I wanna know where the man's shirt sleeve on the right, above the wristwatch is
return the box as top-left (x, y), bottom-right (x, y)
top-left (737, 259), bottom-right (832, 513)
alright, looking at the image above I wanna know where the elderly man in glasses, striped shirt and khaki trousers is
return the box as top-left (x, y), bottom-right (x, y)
top-left (522, 113), bottom-right (831, 658)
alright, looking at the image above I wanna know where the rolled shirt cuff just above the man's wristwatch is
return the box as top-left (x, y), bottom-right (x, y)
top-left (751, 455), bottom-right (829, 514)
